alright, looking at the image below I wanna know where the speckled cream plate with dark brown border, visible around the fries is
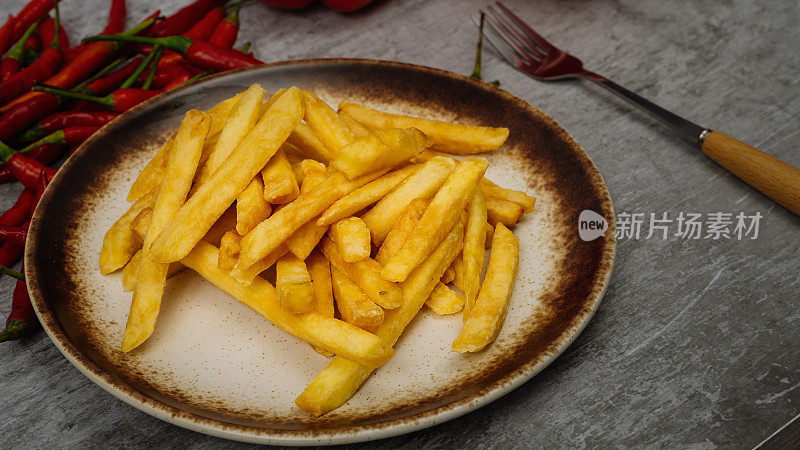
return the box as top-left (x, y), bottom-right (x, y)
top-left (26, 60), bottom-right (615, 445)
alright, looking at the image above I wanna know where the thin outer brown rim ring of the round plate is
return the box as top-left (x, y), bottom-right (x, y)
top-left (25, 58), bottom-right (616, 445)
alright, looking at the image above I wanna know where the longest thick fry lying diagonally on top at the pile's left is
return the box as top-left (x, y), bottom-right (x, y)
top-left (147, 88), bottom-right (303, 267)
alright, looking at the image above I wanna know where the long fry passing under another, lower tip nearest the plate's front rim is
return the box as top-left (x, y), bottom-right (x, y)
top-left (295, 218), bottom-right (464, 416)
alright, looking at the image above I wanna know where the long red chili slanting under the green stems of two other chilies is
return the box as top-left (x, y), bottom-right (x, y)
top-left (0, 11), bottom-right (160, 114)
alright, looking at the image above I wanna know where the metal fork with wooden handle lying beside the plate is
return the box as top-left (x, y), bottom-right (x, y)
top-left (472, 2), bottom-right (800, 216)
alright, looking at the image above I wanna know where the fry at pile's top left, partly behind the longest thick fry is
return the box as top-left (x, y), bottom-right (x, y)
top-left (195, 84), bottom-right (266, 189)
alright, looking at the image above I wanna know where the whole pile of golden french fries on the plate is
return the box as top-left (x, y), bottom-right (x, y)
top-left (100, 84), bottom-right (535, 415)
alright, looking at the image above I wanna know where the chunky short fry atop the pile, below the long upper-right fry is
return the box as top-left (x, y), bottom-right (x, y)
top-left (330, 128), bottom-right (429, 180)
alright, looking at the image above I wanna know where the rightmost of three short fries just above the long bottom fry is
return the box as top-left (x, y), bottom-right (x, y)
top-left (331, 267), bottom-right (383, 333)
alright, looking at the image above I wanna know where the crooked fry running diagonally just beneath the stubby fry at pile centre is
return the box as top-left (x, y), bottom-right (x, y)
top-left (320, 237), bottom-right (403, 309)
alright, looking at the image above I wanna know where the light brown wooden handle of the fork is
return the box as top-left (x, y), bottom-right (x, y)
top-left (701, 131), bottom-right (800, 216)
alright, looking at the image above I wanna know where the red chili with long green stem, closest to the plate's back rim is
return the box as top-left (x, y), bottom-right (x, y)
top-left (84, 34), bottom-right (264, 72)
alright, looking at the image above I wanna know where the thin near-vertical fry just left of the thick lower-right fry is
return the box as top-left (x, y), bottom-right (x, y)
top-left (461, 184), bottom-right (487, 318)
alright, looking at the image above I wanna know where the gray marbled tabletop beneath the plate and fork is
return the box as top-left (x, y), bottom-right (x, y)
top-left (0, 0), bottom-right (800, 449)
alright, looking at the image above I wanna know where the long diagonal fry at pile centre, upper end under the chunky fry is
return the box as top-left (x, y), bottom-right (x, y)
top-left (231, 172), bottom-right (382, 283)
